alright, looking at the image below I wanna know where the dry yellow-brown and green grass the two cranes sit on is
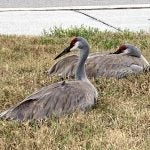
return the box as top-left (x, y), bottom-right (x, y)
top-left (0, 27), bottom-right (150, 150)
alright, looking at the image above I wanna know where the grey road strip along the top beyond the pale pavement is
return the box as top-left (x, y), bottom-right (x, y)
top-left (0, 0), bottom-right (150, 8)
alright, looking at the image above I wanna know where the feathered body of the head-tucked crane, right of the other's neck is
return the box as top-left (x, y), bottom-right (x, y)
top-left (86, 54), bottom-right (144, 78)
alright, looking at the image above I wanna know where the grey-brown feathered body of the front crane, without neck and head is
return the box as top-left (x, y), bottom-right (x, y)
top-left (0, 81), bottom-right (95, 121)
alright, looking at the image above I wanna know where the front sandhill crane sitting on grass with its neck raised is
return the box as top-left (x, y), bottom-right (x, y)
top-left (0, 37), bottom-right (97, 121)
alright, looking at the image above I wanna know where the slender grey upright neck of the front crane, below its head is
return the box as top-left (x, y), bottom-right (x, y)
top-left (75, 46), bottom-right (89, 81)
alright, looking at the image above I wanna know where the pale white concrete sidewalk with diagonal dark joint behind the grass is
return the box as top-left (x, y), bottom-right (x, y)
top-left (0, 4), bottom-right (150, 35)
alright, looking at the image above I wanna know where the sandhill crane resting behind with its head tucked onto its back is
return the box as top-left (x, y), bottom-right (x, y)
top-left (48, 44), bottom-right (149, 78)
